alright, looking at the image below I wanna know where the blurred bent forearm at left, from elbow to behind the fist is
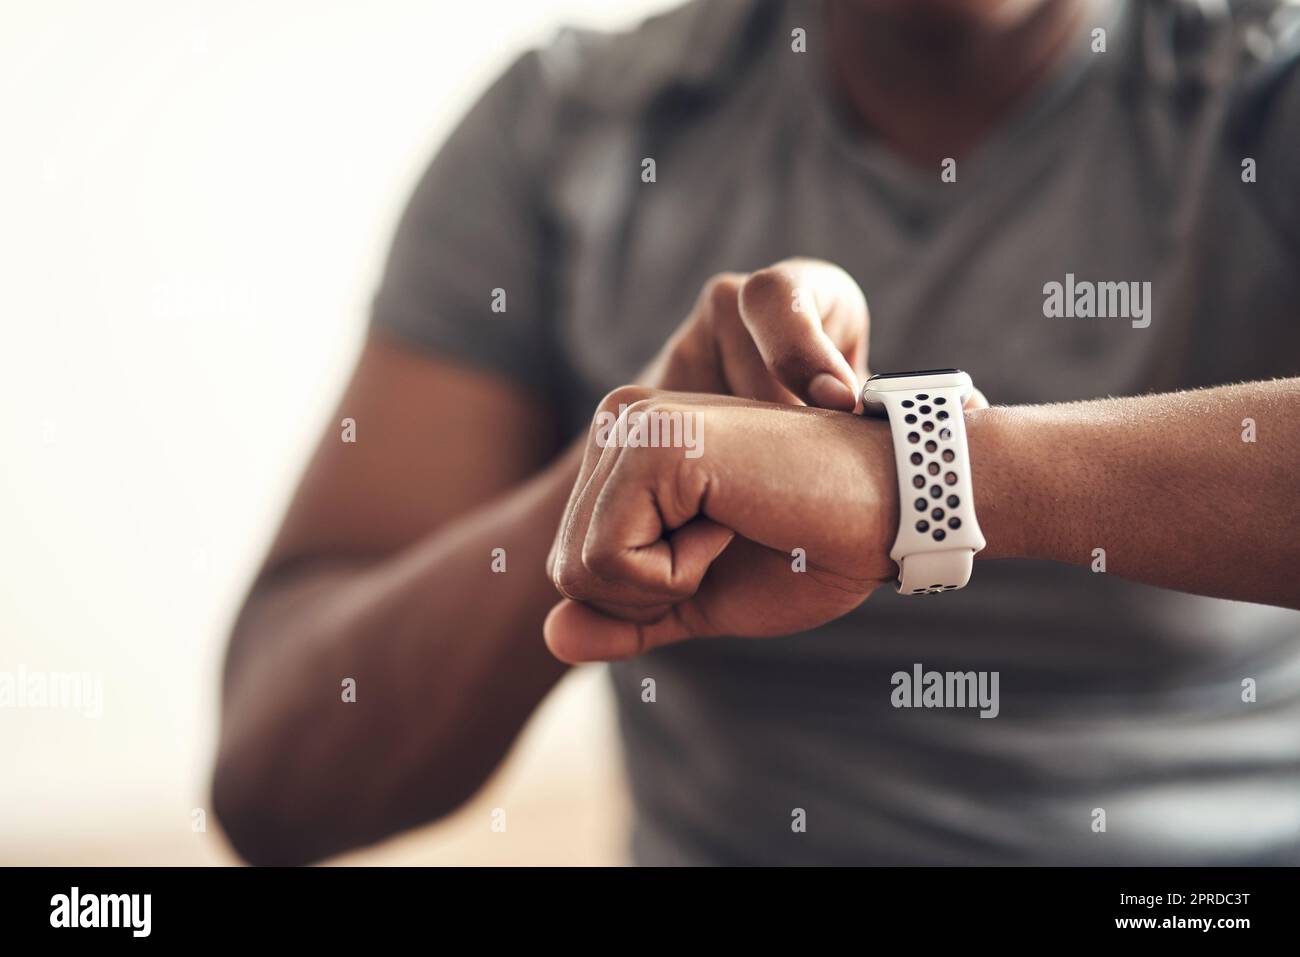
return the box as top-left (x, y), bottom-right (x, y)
top-left (213, 442), bottom-right (577, 862)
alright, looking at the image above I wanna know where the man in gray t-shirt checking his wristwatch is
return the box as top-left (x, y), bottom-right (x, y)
top-left (215, 0), bottom-right (1300, 863)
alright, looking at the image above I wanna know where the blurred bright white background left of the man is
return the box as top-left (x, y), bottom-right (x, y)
top-left (0, 0), bottom-right (668, 865)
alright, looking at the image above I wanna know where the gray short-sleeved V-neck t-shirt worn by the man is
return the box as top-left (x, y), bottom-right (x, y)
top-left (373, 0), bottom-right (1300, 865)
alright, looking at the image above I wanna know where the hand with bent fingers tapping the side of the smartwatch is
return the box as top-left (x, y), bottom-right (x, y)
top-left (638, 259), bottom-right (871, 411)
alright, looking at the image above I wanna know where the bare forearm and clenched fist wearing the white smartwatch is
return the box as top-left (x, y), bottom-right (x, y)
top-left (546, 380), bottom-right (1300, 662)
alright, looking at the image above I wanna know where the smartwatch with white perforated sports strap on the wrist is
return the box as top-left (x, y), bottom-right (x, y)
top-left (862, 369), bottom-right (984, 594)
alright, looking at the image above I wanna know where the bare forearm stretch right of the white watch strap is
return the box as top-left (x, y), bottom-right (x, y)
top-left (967, 378), bottom-right (1300, 609)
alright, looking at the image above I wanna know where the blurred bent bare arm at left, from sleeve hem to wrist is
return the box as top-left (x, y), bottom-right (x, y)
top-left (213, 341), bottom-right (576, 863)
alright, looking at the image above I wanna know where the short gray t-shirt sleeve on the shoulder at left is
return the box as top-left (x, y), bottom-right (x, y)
top-left (371, 53), bottom-right (556, 394)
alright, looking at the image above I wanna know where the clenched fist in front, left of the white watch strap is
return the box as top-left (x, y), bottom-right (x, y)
top-left (545, 386), bottom-right (898, 662)
